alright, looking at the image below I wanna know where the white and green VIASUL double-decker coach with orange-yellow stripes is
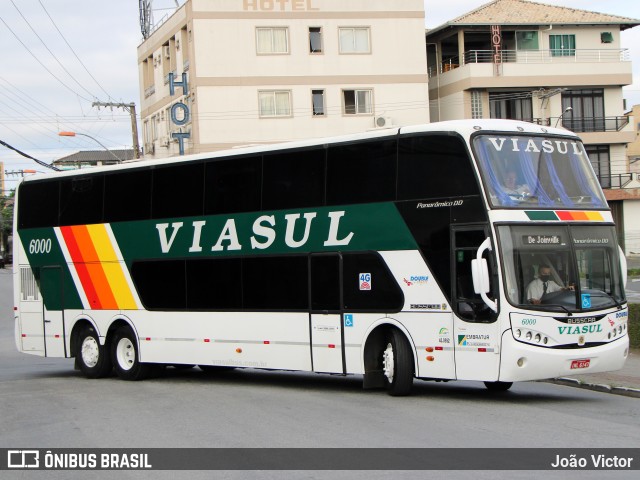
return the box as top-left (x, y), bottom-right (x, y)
top-left (14, 120), bottom-right (629, 395)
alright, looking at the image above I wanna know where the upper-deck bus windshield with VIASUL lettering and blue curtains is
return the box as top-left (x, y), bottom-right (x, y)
top-left (473, 135), bottom-right (607, 209)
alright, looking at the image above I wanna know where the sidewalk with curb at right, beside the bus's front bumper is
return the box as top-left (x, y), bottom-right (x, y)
top-left (549, 349), bottom-right (640, 398)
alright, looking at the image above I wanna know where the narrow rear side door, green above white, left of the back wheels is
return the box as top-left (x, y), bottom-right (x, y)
top-left (40, 267), bottom-right (66, 357)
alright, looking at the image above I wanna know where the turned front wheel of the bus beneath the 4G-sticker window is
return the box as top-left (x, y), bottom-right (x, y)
top-left (382, 329), bottom-right (413, 396)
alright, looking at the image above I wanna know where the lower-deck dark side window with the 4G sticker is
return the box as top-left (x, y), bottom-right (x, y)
top-left (342, 253), bottom-right (404, 312)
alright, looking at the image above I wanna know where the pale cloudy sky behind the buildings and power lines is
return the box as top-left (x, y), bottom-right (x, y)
top-left (0, 0), bottom-right (640, 190)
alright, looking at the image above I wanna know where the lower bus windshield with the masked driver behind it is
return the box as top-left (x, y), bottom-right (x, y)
top-left (498, 225), bottom-right (625, 312)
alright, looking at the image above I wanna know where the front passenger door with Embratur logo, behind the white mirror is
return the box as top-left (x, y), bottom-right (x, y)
top-left (451, 225), bottom-right (501, 381)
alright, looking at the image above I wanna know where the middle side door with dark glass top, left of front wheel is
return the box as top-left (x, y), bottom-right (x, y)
top-left (309, 253), bottom-right (345, 373)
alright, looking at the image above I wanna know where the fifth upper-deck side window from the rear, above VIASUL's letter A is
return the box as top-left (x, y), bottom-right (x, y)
top-left (204, 157), bottom-right (262, 215)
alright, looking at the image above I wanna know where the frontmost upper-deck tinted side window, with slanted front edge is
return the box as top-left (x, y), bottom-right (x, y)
top-left (398, 135), bottom-right (479, 200)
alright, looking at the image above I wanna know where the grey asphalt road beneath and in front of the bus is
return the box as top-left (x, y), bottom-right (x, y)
top-left (0, 270), bottom-right (640, 479)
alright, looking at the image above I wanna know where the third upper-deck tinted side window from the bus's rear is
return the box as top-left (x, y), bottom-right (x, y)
top-left (104, 170), bottom-right (151, 222)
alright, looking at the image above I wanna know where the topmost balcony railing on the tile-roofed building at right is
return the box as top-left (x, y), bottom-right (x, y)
top-left (429, 48), bottom-right (631, 77)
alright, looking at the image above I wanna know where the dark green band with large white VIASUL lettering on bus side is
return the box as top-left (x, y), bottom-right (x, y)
top-left (111, 203), bottom-right (418, 265)
